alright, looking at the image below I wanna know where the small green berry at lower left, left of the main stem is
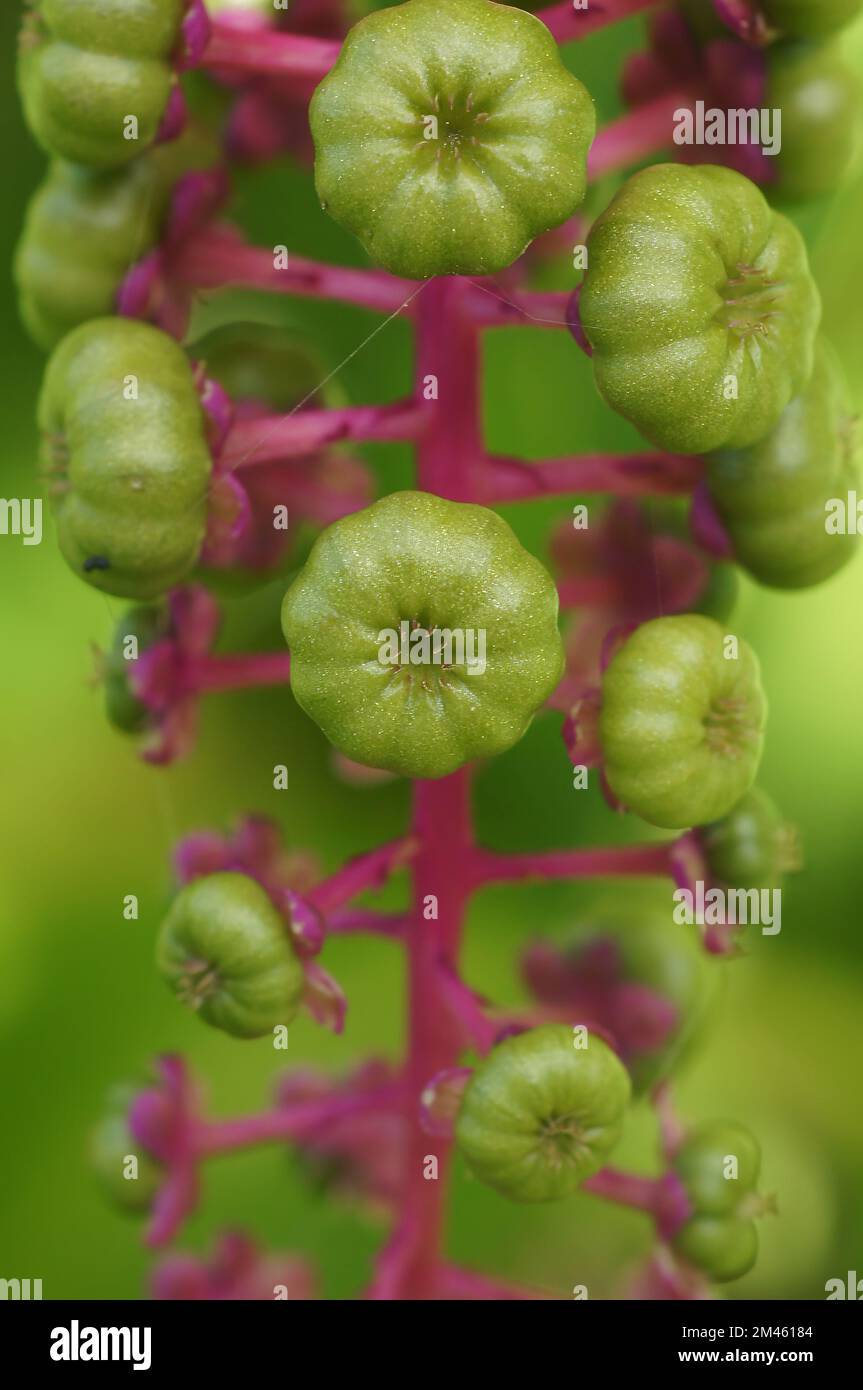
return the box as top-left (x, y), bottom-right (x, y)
top-left (156, 873), bottom-right (304, 1038)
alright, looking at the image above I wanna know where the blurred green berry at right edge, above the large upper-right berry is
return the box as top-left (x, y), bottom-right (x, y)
top-left (764, 43), bottom-right (863, 199)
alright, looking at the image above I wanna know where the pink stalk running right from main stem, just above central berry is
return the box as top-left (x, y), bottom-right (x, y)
top-left (485, 453), bottom-right (703, 502)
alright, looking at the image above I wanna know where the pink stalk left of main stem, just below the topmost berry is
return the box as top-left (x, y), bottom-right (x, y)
top-left (170, 225), bottom-right (418, 314)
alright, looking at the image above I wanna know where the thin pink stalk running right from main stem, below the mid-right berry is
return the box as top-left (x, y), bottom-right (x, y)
top-left (471, 840), bottom-right (675, 887)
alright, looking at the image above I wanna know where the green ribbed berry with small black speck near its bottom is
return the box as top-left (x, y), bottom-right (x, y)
top-left (39, 318), bottom-right (213, 599)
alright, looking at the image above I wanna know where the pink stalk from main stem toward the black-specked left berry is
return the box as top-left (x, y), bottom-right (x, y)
top-left (220, 400), bottom-right (424, 470)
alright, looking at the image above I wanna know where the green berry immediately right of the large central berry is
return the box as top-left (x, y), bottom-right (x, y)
top-left (599, 613), bottom-right (766, 830)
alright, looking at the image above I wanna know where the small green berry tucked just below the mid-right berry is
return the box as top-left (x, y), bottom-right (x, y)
top-left (698, 787), bottom-right (798, 888)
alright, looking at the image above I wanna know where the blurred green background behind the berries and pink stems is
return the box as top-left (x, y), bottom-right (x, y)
top-left (0, 4), bottom-right (863, 1298)
